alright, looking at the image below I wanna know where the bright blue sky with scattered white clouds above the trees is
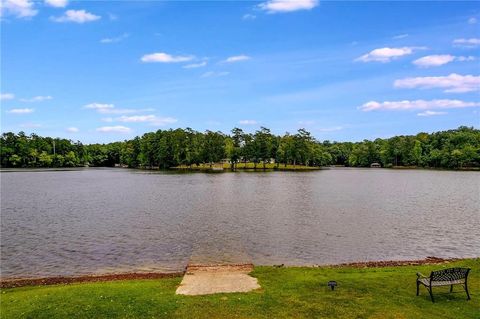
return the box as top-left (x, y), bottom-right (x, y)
top-left (0, 0), bottom-right (480, 143)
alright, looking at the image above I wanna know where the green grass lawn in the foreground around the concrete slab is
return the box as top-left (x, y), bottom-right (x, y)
top-left (0, 259), bottom-right (480, 319)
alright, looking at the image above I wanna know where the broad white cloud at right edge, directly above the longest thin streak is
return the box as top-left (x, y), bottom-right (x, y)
top-left (393, 73), bottom-right (480, 93)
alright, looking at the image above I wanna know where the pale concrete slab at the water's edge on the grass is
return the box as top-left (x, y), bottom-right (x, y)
top-left (176, 264), bottom-right (260, 295)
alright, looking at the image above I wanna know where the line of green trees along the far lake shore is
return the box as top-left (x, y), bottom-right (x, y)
top-left (0, 126), bottom-right (480, 169)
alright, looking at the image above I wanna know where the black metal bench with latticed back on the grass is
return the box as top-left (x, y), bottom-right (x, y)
top-left (417, 268), bottom-right (470, 302)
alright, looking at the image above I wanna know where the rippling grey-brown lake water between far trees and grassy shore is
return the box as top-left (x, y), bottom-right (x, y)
top-left (0, 169), bottom-right (480, 278)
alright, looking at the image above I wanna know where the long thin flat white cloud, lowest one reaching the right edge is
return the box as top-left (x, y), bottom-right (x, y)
top-left (359, 100), bottom-right (480, 112)
